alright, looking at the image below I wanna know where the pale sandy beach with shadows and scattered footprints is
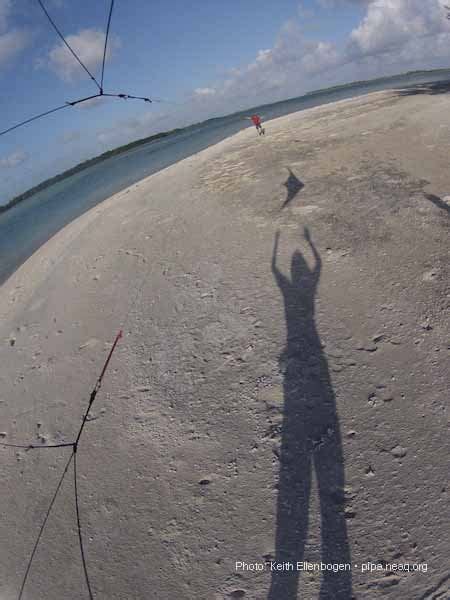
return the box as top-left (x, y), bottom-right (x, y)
top-left (0, 86), bottom-right (450, 600)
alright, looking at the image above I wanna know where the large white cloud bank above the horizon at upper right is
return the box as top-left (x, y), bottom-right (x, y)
top-left (185, 0), bottom-right (450, 114)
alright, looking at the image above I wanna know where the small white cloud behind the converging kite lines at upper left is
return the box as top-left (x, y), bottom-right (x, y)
top-left (45, 29), bottom-right (120, 82)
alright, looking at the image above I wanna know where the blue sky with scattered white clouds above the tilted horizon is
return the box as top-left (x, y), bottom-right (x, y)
top-left (0, 0), bottom-right (450, 204)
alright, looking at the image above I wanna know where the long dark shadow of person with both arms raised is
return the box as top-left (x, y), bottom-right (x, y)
top-left (268, 228), bottom-right (352, 600)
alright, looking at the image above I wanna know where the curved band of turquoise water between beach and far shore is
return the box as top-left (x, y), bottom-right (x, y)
top-left (0, 70), bottom-right (450, 284)
